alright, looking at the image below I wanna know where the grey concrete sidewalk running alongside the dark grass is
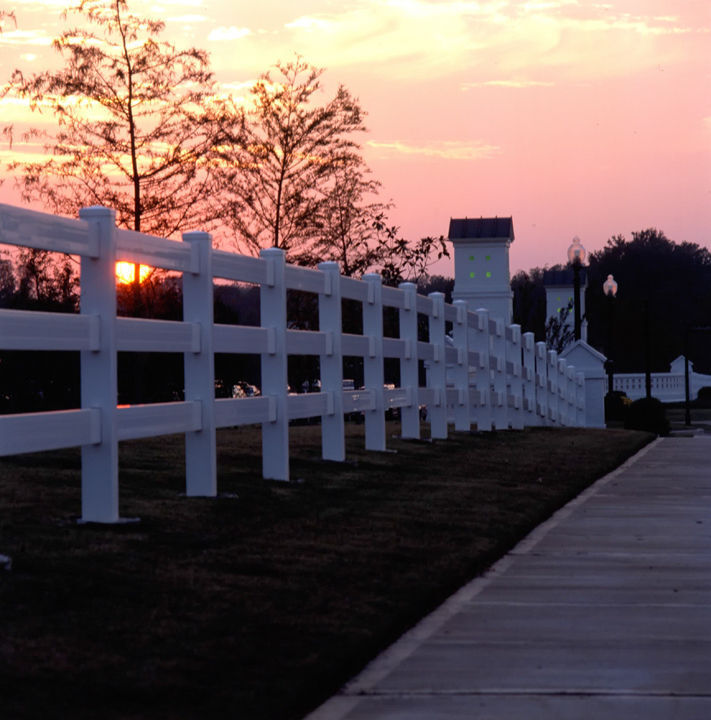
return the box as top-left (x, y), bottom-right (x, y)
top-left (307, 436), bottom-right (711, 720)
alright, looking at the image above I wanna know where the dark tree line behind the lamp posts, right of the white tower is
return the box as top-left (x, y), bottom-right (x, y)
top-left (511, 228), bottom-right (711, 373)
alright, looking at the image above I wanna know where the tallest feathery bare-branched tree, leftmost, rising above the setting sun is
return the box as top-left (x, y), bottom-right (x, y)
top-left (3, 0), bottom-right (214, 282)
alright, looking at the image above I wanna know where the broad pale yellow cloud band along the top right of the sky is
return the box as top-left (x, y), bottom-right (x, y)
top-left (262, 0), bottom-right (704, 87)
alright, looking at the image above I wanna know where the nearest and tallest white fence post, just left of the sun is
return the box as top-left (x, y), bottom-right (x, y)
top-left (79, 207), bottom-right (119, 523)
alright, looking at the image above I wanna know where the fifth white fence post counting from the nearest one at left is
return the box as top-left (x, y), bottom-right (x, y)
top-left (363, 273), bottom-right (386, 451)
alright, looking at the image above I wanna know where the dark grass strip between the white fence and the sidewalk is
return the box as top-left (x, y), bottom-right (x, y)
top-left (0, 425), bottom-right (651, 720)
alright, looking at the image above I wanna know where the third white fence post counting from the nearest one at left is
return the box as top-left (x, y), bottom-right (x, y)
top-left (259, 248), bottom-right (289, 480)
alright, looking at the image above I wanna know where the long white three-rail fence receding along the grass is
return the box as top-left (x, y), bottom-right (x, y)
top-left (0, 205), bottom-right (585, 522)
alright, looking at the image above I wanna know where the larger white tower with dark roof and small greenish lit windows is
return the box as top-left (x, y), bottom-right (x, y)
top-left (449, 217), bottom-right (514, 325)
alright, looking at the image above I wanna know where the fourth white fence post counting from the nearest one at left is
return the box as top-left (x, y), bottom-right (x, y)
top-left (318, 262), bottom-right (346, 462)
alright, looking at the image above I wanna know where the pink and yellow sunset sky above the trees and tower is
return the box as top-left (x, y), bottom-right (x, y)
top-left (0, 0), bottom-right (711, 274)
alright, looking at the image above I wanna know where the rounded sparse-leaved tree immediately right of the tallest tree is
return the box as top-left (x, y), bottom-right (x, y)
top-left (216, 57), bottom-right (365, 255)
